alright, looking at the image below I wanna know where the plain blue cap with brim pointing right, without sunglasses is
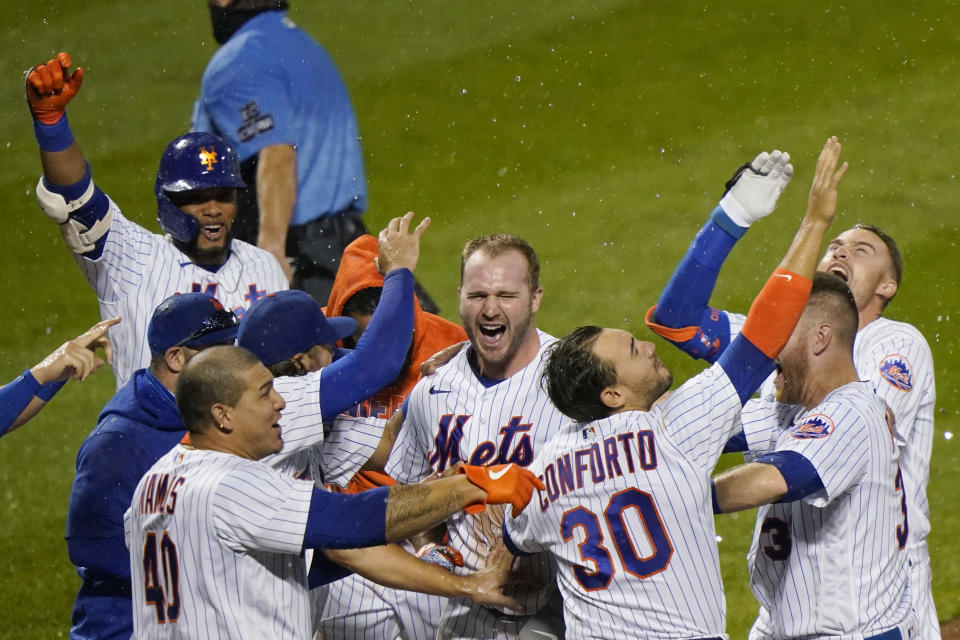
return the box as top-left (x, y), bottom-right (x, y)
top-left (237, 289), bottom-right (357, 366)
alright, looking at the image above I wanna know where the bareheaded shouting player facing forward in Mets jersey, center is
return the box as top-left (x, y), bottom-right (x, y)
top-left (386, 235), bottom-right (576, 638)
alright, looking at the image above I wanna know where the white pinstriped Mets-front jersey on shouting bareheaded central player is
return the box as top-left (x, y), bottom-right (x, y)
top-left (386, 331), bottom-right (566, 614)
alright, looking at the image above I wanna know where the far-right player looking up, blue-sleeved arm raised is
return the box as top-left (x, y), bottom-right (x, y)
top-left (647, 136), bottom-right (940, 638)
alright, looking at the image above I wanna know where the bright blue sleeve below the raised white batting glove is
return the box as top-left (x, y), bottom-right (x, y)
top-left (650, 206), bottom-right (746, 363)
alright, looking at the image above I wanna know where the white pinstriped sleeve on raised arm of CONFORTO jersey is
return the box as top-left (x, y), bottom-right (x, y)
top-left (659, 364), bottom-right (741, 471)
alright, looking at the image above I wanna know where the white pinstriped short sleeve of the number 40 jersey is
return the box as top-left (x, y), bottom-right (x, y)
top-left (212, 461), bottom-right (313, 554)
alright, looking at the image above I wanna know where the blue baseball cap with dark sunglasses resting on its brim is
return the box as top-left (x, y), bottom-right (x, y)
top-left (147, 293), bottom-right (240, 356)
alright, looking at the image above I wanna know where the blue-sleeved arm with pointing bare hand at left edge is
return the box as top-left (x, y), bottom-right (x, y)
top-left (0, 318), bottom-right (120, 436)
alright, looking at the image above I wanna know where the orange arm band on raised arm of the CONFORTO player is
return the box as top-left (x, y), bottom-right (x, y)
top-left (741, 268), bottom-right (813, 360)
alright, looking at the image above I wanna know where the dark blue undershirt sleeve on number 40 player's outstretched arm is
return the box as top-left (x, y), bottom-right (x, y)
top-left (303, 487), bottom-right (390, 549)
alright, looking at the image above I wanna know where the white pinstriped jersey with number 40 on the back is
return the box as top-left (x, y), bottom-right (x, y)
top-left (124, 445), bottom-right (313, 640)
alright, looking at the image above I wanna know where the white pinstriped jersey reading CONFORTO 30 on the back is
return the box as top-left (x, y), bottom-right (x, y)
top-left (506, 364), bottom-right (740, 638)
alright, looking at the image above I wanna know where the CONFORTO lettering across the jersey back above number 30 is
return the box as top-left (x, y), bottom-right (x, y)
top-left (540, 426), bottom-right (657, 511)
